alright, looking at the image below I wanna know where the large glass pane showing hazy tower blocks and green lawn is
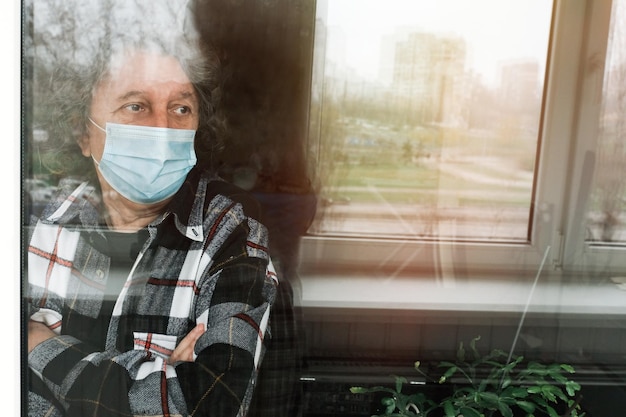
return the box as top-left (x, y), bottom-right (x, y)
top-left (310, 0), bottom-right (552, 242)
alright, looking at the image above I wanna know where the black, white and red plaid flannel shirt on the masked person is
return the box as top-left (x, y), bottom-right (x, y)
top-left (27, 169), bottom-right (277, 417)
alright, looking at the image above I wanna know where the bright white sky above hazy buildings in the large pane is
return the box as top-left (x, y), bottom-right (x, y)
top-left (318, 0), bottom-right (552, 85)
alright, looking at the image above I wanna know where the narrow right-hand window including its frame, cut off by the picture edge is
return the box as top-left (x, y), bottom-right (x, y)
top-left (562, 0), bottom-right (626, 272)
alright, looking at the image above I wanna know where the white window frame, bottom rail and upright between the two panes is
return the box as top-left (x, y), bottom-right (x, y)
top-left (300, 0), bottom-right (626, 278)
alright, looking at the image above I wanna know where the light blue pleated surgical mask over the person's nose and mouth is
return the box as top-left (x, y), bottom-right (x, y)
top-left (89, 118), bottom-right (196, 204)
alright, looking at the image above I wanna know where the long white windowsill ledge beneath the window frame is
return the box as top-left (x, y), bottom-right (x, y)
top-left (295, 274), bottom-right (626, 316)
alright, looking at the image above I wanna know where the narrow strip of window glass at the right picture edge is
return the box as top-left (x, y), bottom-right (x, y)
top-left (587, 0), bottom-right (626, 244)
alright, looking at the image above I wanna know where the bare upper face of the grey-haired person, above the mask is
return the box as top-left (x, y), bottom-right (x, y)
top-left (79, 52), bottom-right (199, 161)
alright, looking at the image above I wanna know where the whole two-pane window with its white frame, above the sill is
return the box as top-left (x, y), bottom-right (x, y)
top-left (303, 0), bottom-right (624, 275)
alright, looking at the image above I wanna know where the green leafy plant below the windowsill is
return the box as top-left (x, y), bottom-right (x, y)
top-left (350, 337), bottom-right (585, 417)
